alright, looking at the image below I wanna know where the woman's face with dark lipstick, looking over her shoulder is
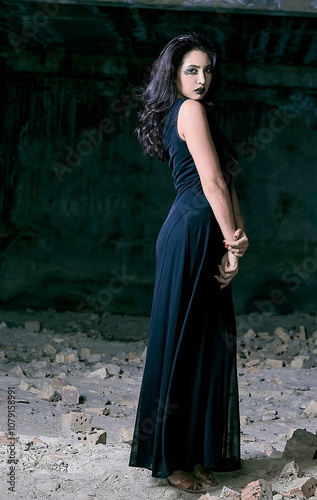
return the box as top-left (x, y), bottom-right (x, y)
top-left (175, 50), bottom-right (212, 101)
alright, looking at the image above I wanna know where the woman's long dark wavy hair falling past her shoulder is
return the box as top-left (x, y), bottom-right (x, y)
top-left (135, 33), bottom-right (220, 160)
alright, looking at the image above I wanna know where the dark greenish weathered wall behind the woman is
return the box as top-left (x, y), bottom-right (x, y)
top-left (0, 2), bottom-right (317, 314)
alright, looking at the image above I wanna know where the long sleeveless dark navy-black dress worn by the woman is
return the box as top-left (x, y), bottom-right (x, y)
top-left (130, 99), bottom-right (241, 477)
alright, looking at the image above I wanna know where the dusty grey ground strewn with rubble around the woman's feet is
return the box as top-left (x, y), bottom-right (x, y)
top-left (0, 310), bottom-right (317, 500)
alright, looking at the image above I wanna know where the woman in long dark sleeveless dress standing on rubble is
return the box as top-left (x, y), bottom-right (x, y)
top-left (130, 34), bottom-right (248, 493)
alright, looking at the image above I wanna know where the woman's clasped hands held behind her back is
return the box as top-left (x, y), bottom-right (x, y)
top-left (214, 229), bottom-right (249, 288)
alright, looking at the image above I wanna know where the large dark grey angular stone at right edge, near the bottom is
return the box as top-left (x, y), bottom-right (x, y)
top-left (282, 429), bottom-right (317, 461)
